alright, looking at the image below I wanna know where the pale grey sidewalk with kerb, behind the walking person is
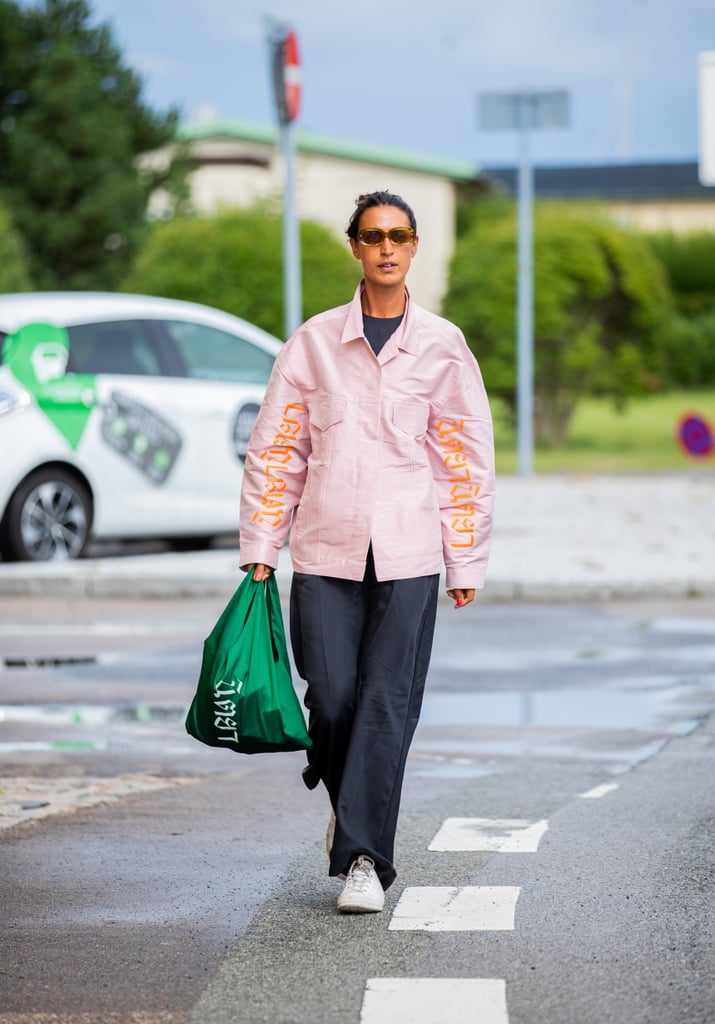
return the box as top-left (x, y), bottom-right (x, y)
top-left (0, 471), bottom-right (715, 601)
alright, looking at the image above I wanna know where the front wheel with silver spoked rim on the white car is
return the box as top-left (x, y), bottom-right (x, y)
top-left (2, 468), bottom-right (92, 562)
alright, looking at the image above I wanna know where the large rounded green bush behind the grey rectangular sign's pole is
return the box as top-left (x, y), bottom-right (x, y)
top-left (444, 206), bottom-right (670, 444)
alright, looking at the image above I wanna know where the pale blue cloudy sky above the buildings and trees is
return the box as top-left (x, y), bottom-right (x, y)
top-left (69, 0), bottom-right (715, 167)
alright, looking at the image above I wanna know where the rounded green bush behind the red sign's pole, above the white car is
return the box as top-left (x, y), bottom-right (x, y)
top-left (122, 206), bottom-right (360, 337)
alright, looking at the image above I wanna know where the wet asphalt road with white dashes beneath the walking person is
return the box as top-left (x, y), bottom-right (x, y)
top-left (0, 597), bottom-right (715, 1024)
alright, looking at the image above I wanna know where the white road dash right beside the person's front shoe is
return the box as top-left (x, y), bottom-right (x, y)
top-left (389, 886), bottom-right (521, 932)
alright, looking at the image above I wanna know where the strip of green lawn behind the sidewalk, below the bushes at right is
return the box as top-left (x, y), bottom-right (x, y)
top-left (493, 391), bottom-right (715, 473)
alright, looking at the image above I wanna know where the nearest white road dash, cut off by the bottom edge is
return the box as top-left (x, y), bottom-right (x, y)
top-left (360, 978), bottom-right (509, 1024)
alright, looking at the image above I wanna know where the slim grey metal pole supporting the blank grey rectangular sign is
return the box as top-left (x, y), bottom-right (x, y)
top-left (516, 94), bottom-right (534, 476)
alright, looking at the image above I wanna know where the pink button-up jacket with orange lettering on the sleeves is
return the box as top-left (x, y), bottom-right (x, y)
top-left (240, 284), bottom-right (494, 589)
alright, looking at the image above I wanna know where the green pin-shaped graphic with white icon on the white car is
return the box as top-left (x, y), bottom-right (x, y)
top-left (3, 324), bottom-right (97, 451)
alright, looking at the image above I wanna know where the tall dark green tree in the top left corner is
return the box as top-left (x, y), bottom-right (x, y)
top-left (0, 0), bottom-right (182, 289)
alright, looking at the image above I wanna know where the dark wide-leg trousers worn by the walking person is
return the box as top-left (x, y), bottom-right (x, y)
top-left (290, 550), bottom-right (439, 889)
